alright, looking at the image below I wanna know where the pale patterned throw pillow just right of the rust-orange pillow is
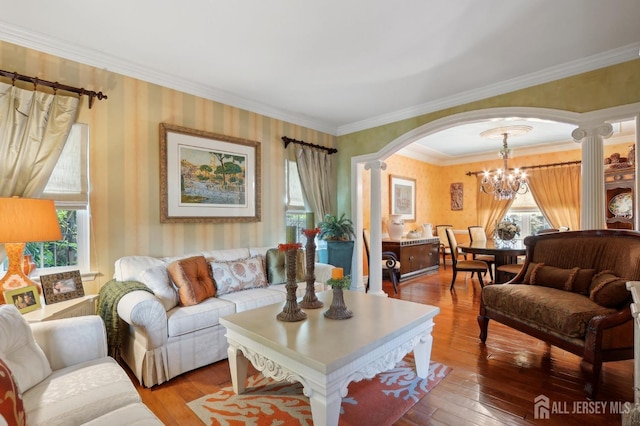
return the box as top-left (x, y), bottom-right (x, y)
top-left (211, 256), bottom-right (269, 295)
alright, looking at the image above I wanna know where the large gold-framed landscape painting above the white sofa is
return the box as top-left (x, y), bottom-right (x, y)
top-left (160, 123), bottom-right (261, 223)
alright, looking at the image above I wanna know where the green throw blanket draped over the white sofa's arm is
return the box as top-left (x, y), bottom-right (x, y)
top-left (98, 280), bottom-right (153, 359)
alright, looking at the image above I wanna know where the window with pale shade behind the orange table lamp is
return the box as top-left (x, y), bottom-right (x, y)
top-left (0, 124), bottom-right (89, 275)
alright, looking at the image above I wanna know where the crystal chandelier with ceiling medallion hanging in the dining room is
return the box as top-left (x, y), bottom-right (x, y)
top-left (480, 126), bottom-right (532, 200)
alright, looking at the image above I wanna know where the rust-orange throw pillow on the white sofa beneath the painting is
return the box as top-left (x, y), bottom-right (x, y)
top-left (167, 256), bottom-right (216, 306)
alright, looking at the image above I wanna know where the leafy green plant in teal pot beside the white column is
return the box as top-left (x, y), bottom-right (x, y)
top-left (318, 213), bottom-right (356, 275)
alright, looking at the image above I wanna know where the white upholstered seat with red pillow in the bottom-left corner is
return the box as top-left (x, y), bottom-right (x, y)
top-left (0, 305), bottom-right (162, 426)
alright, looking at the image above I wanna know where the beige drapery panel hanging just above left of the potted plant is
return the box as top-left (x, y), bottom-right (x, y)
top-left (295, 146), bottom-right (335, 222)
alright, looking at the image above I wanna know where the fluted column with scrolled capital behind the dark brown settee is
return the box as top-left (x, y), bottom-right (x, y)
top-left (571, 123), bottom-right (613, 229)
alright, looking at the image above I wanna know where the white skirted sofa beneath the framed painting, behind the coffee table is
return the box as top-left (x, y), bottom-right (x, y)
top-left (114, 247), bottom-right (334, 387)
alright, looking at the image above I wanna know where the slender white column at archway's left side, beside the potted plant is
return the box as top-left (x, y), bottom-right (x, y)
top-left (364, 160), bottom-right (387, 296)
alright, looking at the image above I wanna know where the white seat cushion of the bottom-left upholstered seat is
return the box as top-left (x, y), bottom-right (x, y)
top-left (24, 357), bottom-right (141, 426)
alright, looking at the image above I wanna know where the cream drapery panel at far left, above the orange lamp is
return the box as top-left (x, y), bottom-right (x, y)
top-left (0, 83), bottom-right (79, 198)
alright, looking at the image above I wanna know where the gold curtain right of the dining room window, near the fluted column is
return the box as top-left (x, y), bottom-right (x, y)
top-left (527, 164), bottom-right (582, 231)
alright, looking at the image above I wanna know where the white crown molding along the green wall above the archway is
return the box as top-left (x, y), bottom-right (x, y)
top-left (338, 42), bottom-right (640, 136)
